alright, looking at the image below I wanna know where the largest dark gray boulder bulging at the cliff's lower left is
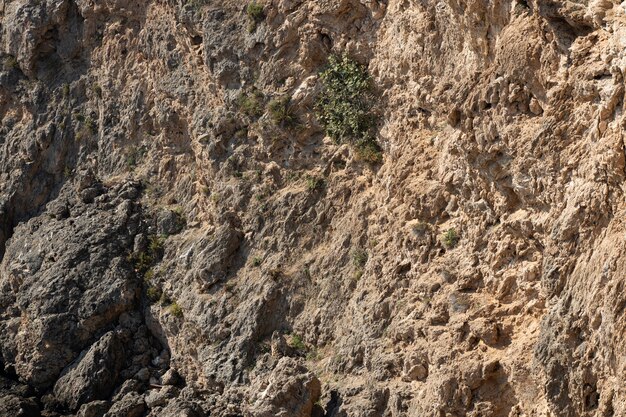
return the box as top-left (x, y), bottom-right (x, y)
top-left (0, 183), bottom-right (140, 390)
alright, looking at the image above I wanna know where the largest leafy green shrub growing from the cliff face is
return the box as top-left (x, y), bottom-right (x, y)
top-left (315, 55), bottom-right (382, 163)
